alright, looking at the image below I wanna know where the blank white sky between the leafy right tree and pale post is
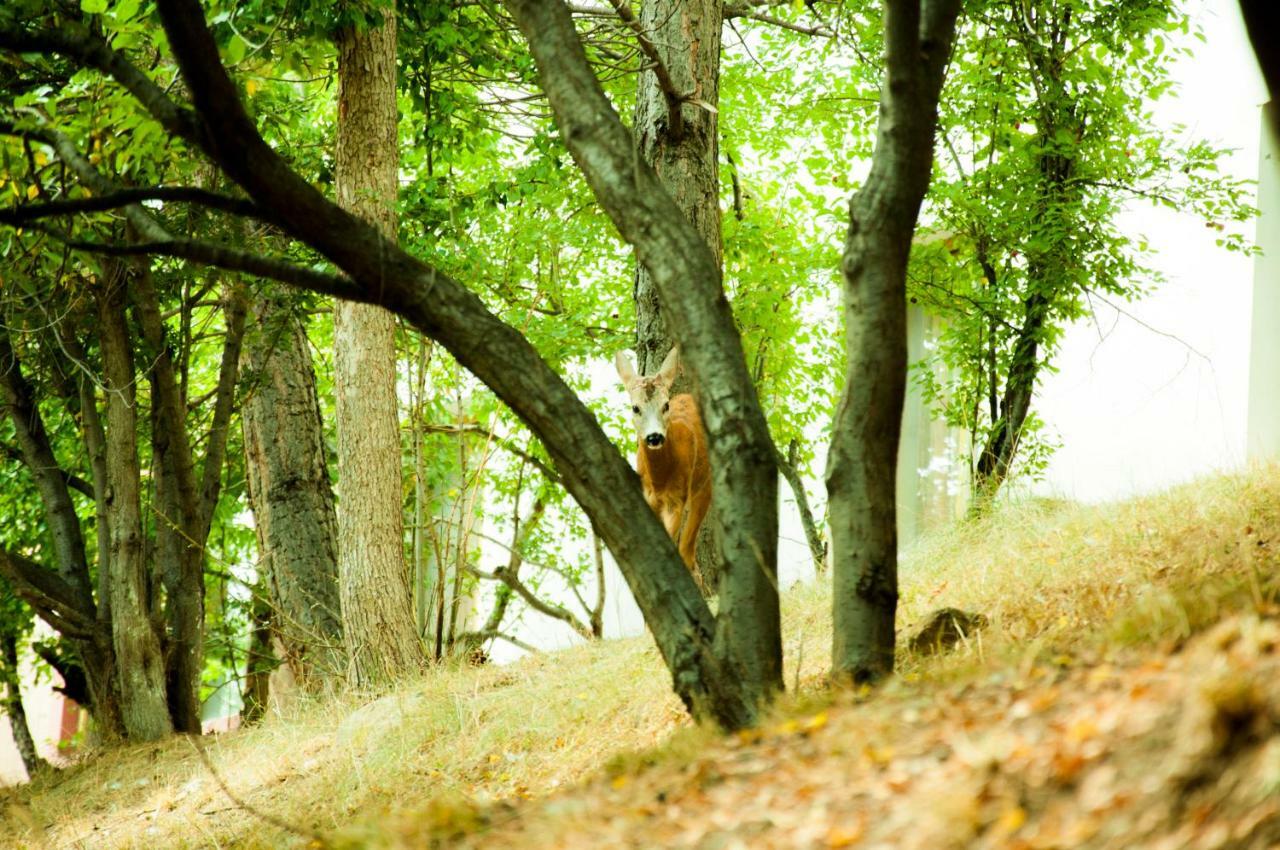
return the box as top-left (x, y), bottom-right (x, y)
top-left (1037, 0), bottom-right (1266, 501)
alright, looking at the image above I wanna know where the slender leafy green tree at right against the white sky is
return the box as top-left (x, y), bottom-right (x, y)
top-left (913, 0), bottom-right (1251, 511)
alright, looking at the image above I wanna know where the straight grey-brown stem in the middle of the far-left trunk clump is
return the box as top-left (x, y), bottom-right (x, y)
top-left (97, 268), bottom-right (173, 741)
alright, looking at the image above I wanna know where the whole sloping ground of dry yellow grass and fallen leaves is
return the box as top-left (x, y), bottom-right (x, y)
top-left (0, 467), bottom-right (1280, 850)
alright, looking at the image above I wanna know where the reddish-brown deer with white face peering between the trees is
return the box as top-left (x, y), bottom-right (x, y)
top-left (614, 348), bottom-right (712, 588)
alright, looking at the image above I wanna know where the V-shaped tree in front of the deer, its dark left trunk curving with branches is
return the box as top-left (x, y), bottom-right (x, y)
top-left (0, 0), bottom-right (781, 728)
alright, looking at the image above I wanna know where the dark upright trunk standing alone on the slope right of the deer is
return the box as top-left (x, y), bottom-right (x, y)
top-left (827, 0), bottom-right (960, 684)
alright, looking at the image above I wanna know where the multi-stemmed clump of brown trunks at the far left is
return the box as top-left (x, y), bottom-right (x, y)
top-left (0, 117), bottom-right (244, 740)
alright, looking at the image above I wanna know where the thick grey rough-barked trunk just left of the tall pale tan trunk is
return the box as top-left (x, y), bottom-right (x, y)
top-left (241, 290), bottom-right (346, 690)
